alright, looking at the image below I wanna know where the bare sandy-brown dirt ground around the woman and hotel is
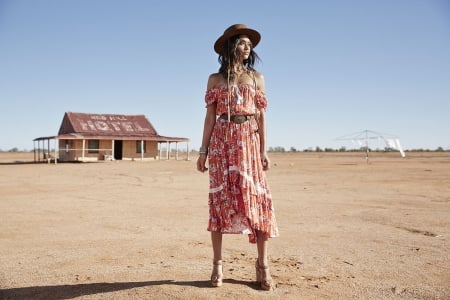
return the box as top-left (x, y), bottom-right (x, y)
top-left (0, 152), bottom-right (450, 299)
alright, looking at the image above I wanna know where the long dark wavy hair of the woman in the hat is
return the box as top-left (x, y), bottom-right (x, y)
top-left (218, 35), bottom-right (261, 81)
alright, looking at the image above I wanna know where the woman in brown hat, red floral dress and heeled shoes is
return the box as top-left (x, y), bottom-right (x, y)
top-left (197, 24), bottom-right (278, 290)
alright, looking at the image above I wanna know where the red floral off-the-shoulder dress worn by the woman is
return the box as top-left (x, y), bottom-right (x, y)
top-left (205, 84), bottom-right (278, 243)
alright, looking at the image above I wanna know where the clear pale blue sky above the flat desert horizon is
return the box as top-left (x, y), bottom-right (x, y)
top-left (0, 0), bottom-right (450, 150)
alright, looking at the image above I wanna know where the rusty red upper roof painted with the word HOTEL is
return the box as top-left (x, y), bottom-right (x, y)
top-left (58, 112), bottom-right (158, 137)
